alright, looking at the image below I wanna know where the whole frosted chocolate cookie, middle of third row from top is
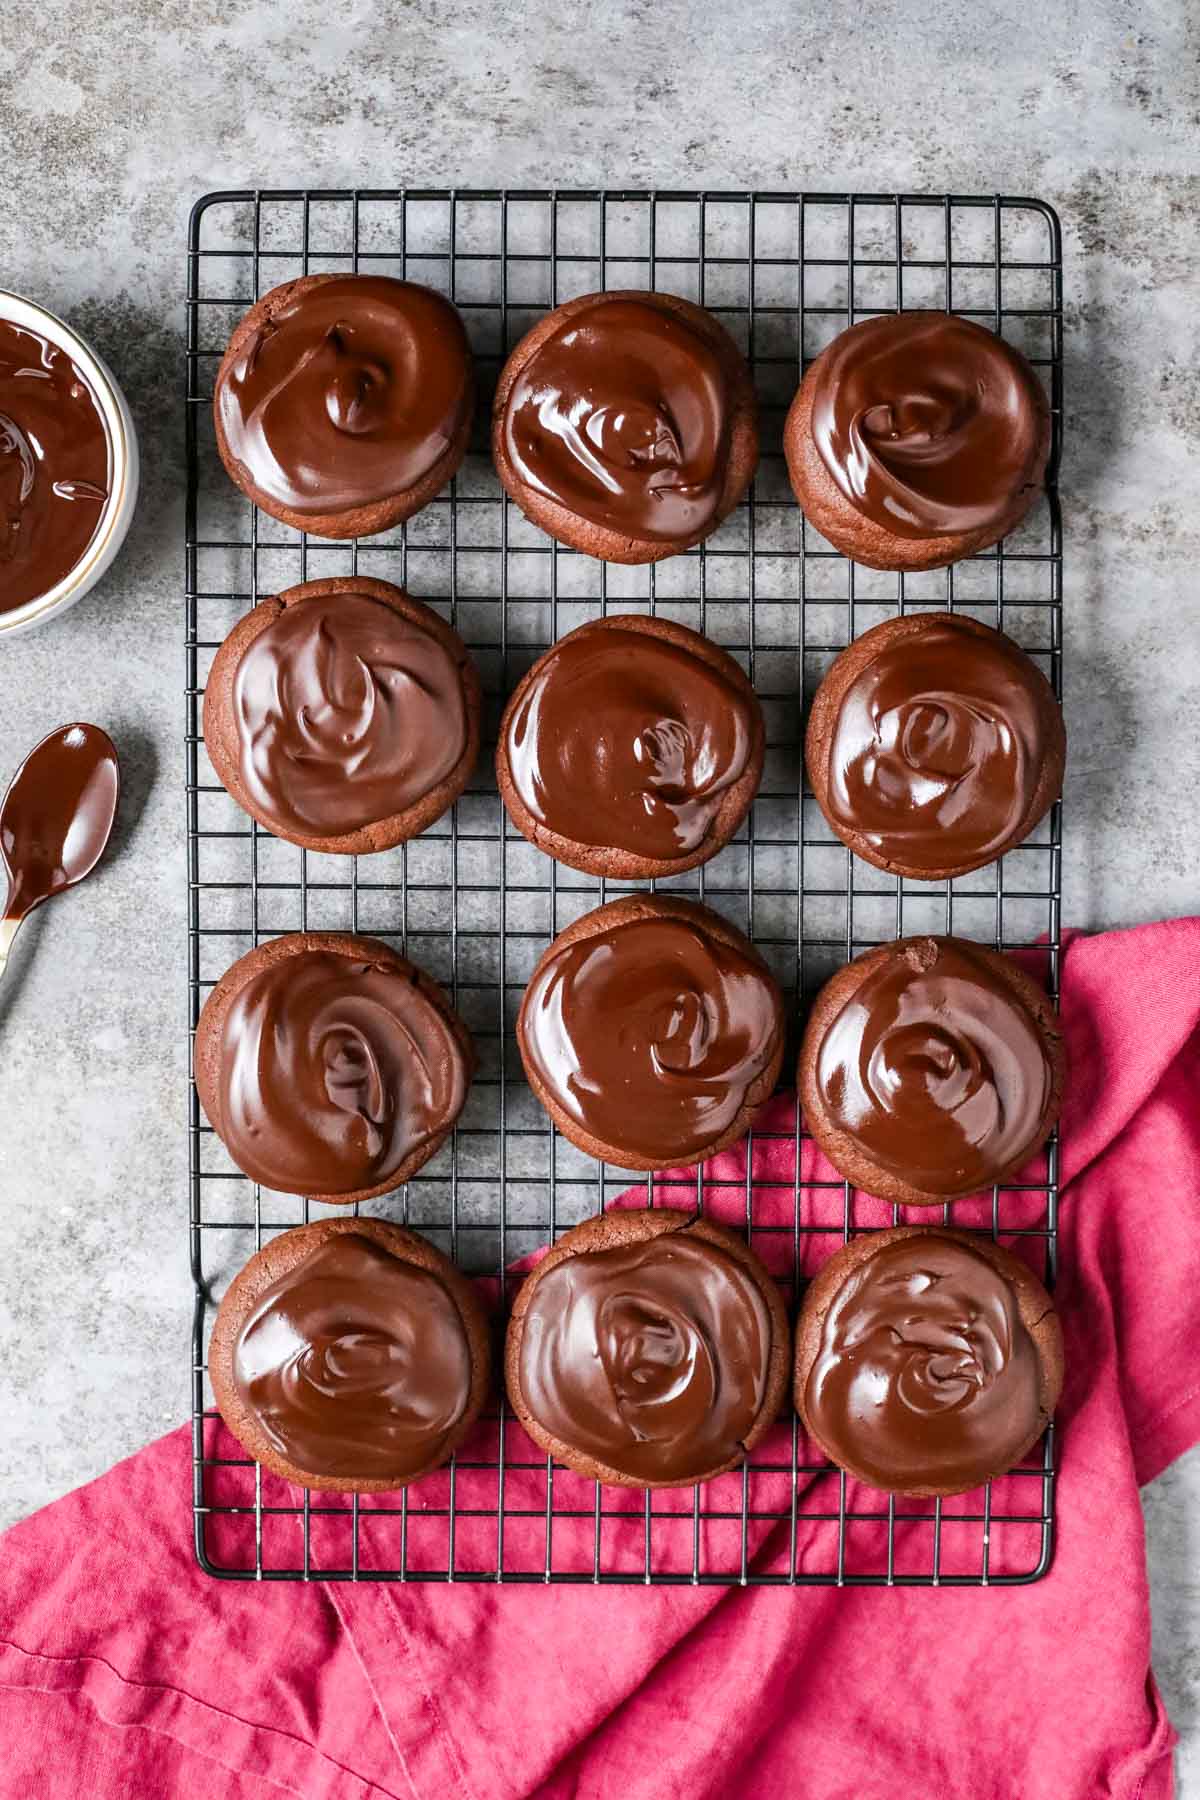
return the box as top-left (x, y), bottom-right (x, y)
top-left (516, 895), bottom-right (784, 1170)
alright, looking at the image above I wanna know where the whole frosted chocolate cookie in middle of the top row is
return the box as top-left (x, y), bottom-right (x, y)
top-left (491, 292), bottom-right (757, 563)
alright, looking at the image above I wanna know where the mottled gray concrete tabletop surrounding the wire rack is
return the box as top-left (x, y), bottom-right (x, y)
top-left (0, 0), bottom-right (1200, 1795)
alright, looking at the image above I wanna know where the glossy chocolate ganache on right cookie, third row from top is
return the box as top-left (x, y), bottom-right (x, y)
top-left (817, 938), bottom-right (1052, 1197)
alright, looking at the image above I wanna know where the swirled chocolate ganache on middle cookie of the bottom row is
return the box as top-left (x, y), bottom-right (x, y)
top-left (520, 1231), bottom-right (770, 1481)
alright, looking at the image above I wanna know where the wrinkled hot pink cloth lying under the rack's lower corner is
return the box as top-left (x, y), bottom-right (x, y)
top-left (0, 920), bottom-right (1200, 1800)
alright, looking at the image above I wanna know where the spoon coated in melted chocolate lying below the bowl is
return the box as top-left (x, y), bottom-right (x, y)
top-left (0, 725), bottom-right (121, 976)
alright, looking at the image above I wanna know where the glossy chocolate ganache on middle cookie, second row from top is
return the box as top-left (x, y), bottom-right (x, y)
top-left (506, 626), bottom-right (754, 862)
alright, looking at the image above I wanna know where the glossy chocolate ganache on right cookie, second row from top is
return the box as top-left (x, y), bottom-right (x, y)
top-left (828, 616), bottom-right (1045, 869)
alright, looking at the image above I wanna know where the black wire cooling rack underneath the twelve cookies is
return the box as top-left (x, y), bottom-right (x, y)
top-left (185, 189), bottom-right (1063, 1586)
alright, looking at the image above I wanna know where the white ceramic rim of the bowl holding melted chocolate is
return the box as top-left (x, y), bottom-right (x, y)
top-left (0, 292), bottom-right (139, 643)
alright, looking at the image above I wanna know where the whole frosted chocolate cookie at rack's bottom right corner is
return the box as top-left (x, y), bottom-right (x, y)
top-left (795, 1226), bottom-right (1063, 1496)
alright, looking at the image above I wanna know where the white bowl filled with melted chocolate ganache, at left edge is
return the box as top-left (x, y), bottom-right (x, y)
top-left (0, 292), bottom-right (139, 639)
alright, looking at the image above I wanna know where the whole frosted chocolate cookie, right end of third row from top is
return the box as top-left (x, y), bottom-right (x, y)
top-left (797, 938), bottom-right (1065, 1206)
